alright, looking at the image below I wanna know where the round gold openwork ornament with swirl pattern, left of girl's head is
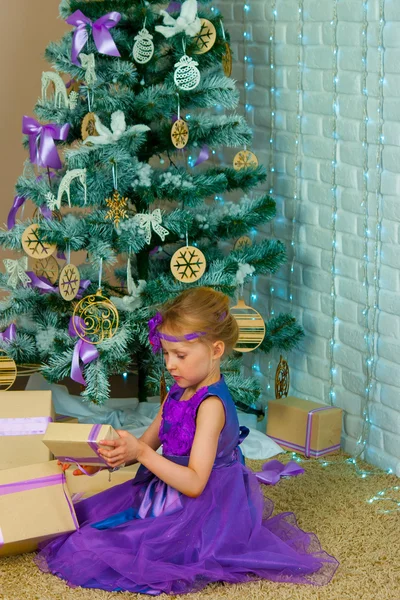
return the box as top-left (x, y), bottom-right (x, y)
top-left (72, 288), bottom-right (119, 345)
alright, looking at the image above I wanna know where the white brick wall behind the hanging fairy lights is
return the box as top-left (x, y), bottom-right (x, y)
top-left (217, 0), bottom-right (400, 476)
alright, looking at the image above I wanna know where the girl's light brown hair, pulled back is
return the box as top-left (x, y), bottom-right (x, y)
top-left (159, 286), bottom-right (239, 354)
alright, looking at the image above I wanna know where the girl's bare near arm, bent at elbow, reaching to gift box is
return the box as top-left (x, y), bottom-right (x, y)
top-left (100, 396), bottom-right (225, 498)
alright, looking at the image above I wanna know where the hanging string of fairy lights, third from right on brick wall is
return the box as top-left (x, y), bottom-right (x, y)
top-left (329, 0), bottom-right (339, 405)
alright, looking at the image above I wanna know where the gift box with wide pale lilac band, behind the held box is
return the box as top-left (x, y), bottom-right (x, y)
top-left (0, 390), bottom-right (54, 469)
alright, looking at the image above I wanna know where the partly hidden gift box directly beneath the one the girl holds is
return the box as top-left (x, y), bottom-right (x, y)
top-left (65, 463), bottom-right (140, 503)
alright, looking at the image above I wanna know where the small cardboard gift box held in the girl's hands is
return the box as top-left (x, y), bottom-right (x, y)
top-left (42, 423), bottom-right (119, 467)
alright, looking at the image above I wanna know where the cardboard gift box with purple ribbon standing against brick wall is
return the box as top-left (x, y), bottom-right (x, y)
top-left (267, 396), bottom-right (342, 457)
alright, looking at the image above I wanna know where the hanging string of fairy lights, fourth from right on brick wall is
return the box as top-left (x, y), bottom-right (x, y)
top-left (289, 0), bottom-right (304, 313)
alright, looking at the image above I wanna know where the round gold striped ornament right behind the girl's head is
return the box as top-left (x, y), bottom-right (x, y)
top-left (230, 298), bottom-right (265, 352)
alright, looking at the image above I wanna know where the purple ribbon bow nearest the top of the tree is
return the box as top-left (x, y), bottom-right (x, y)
top-left (65, 10), bottom-right (121, 67)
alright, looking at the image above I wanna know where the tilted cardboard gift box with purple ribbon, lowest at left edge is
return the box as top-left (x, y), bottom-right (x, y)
top-left (0, 461), bottom-right (78, 556)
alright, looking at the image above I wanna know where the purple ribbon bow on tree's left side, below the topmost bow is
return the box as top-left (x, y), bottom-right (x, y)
top-left (22, 116), bottom-right (70, 169)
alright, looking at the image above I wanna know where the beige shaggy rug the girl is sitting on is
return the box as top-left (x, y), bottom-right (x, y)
top-left (0, 453), bottom-right (400, 600)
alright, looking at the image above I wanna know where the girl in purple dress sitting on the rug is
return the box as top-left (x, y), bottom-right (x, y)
top-left (35, 287), bottom-right (338, 595)
